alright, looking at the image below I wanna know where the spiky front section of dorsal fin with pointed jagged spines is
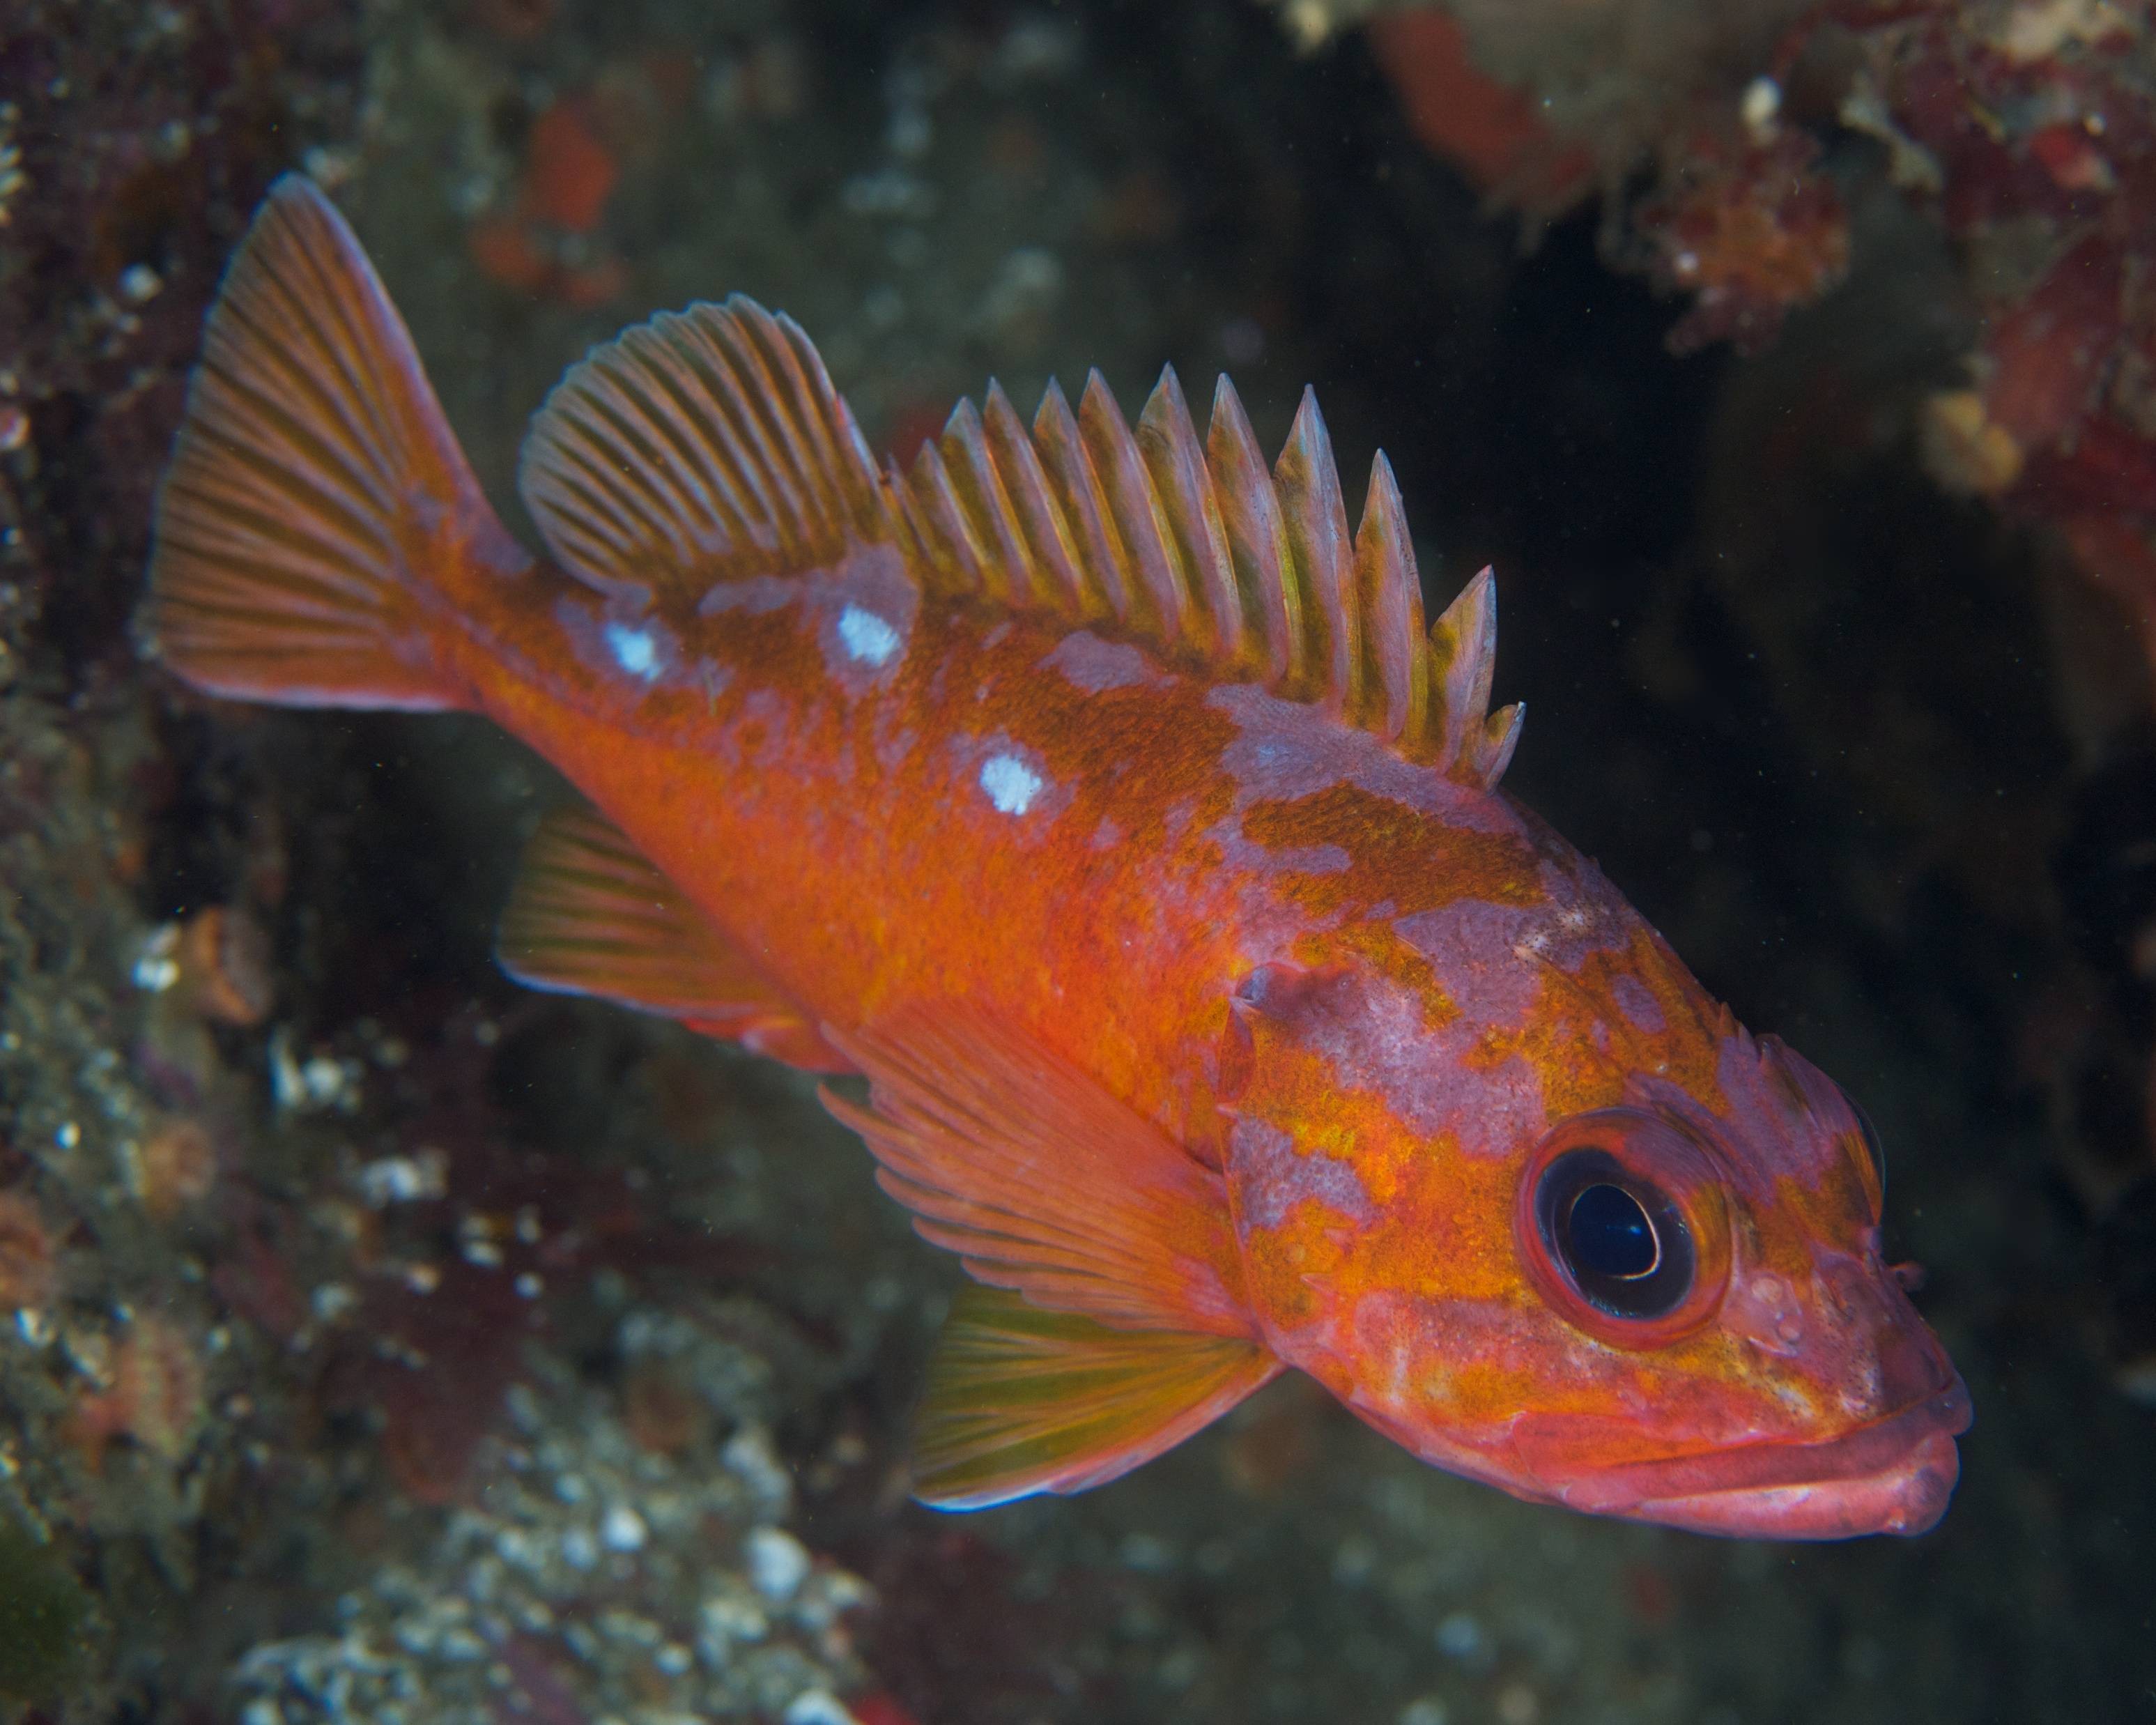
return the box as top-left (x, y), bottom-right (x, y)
top-left (891, 369), bottom-right (1520, 787)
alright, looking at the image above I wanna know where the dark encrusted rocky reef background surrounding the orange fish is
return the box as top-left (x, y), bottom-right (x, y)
top-left (0, 0), bottom-right (2156, 1725)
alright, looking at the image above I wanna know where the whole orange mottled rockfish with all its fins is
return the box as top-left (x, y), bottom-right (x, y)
top-left (146, 179), bottom-right (1969, 1538)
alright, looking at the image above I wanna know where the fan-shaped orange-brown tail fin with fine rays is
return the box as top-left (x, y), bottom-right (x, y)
top-left (144, 175), bottom-right (509, 710)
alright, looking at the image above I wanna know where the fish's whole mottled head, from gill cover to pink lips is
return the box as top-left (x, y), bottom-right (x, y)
top-left (1229, 961), bottom-right (1971, 1540)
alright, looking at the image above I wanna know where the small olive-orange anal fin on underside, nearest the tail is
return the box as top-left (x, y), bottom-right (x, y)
top-left (496, 808), bottom-right (852, 1072)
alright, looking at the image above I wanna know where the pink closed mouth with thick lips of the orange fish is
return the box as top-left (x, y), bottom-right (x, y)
top-left (1555, 1367), bottom-right (1973, 1540)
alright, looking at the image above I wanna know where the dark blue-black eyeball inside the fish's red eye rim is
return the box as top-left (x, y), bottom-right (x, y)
top-left (1535, 1147), bottom-right (1693, 1317)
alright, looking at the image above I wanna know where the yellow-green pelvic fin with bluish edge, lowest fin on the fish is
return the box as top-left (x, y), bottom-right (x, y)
top-left (914, 1287), bottom-right (1283, 1510)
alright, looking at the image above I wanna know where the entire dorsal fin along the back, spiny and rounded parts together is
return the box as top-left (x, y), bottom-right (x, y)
top-left (520, 296), bottom-right (1520, 787)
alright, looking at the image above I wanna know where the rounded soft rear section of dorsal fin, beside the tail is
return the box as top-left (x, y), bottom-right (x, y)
top-left (518, 304), bottom-right (895, 597)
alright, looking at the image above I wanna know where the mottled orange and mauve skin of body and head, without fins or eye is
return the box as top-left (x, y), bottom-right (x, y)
top-left (420, 521), bottom-right (1966, 1538)
